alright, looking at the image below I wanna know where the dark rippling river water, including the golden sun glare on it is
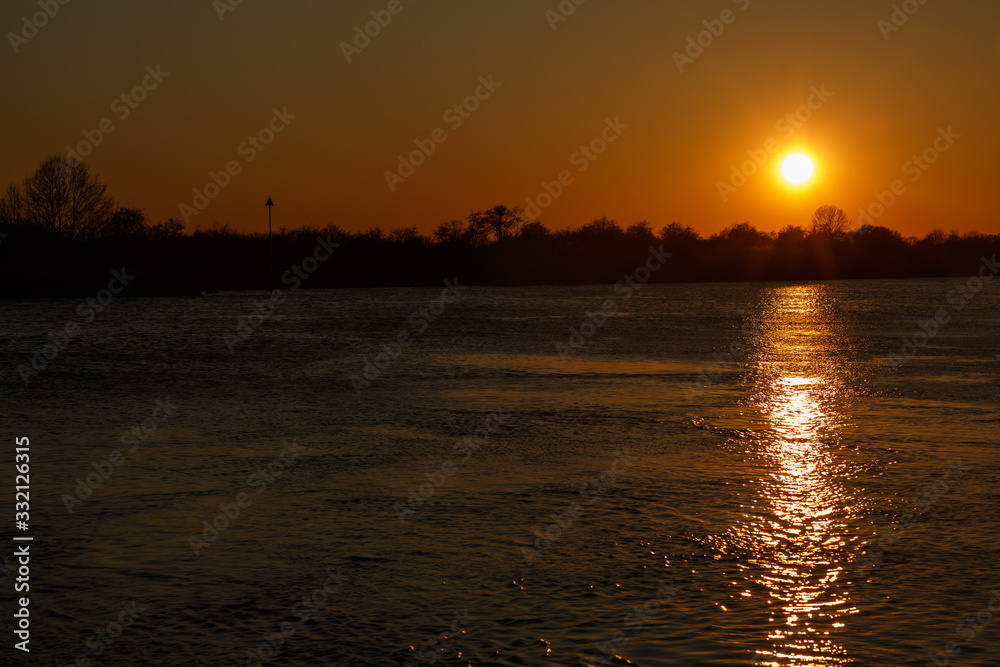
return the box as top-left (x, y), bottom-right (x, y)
top-left (0, 280), bottom-right (1000, 667)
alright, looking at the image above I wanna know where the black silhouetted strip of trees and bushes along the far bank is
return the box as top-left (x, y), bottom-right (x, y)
top-left (0, 156), bottom-right (1000, 297)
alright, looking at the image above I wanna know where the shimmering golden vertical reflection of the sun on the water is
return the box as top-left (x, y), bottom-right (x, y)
top-left (736, 285), bottom-right (857, 667)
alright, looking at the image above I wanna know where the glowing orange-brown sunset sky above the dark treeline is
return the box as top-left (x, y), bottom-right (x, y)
top-left (0, 0), bottom-right (1000, 235)
